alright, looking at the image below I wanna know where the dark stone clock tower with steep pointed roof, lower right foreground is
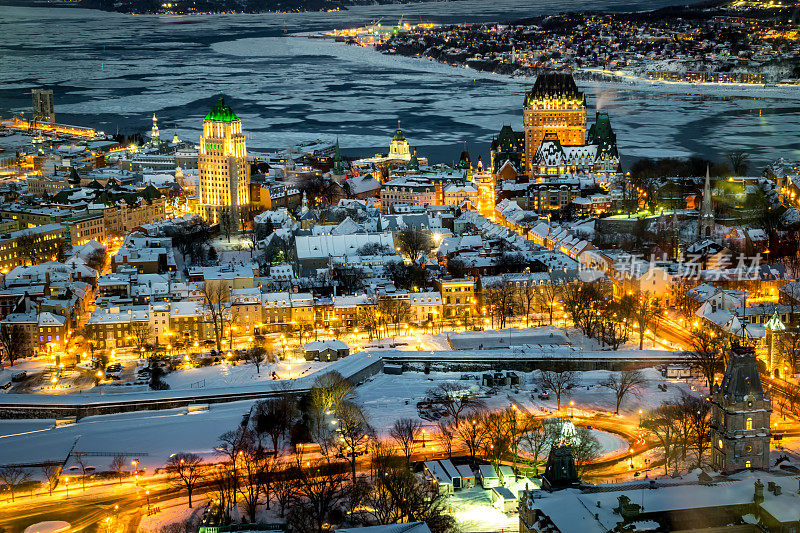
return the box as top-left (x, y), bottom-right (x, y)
top-left (711, 345), bottom-right (772, 473)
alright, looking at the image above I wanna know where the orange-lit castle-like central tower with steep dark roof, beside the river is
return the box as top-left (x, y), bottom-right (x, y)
top-left (523, 73), bottom-right (586, 172)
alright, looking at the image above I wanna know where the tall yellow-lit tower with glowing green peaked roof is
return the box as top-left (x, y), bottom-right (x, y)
top-left (197, 96), bottom-right (250, 229)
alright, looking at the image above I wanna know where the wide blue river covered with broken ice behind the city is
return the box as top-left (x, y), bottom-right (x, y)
top-left (0, 0), bottom-right (800, 163)
